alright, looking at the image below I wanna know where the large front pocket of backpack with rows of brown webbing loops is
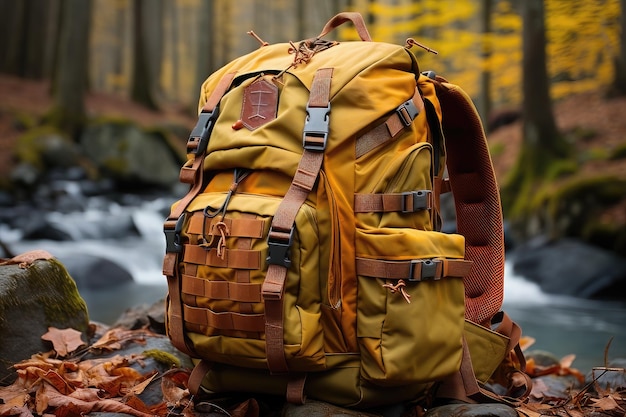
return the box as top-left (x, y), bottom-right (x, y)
top-left (181, 192), bottom-right (324, 370)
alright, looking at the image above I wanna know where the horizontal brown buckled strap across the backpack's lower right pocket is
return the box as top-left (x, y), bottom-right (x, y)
top-left (356, 258), bottom-right (472, 281)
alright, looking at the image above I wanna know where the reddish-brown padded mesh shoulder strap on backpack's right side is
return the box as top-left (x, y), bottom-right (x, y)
top-left (432, 77), bottom-right (504, 325)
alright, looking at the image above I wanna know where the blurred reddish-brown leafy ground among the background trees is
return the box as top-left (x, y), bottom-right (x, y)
top-left (0, 75), bottom-right (626, 219)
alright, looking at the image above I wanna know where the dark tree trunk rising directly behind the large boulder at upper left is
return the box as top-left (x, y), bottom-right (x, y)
top-left (131, 0), bottom-right (163, 110)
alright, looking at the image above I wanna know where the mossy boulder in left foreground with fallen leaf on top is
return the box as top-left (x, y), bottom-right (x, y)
top-left (0, 251), bottom-right (89, 380)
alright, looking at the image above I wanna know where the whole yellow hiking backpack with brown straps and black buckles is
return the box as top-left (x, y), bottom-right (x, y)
top-left (163, 13), bottom-right (526, 407)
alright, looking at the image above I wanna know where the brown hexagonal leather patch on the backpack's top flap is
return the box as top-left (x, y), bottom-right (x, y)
top-left (241, 78), bottom-right (278, 130)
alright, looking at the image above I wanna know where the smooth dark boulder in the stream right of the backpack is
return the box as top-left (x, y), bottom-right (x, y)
top-left (511, 238), bottom-right (626, 300)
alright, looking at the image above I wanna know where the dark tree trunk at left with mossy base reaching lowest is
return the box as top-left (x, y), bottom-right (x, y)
top-left (50, 0), bottom-right (91, 138)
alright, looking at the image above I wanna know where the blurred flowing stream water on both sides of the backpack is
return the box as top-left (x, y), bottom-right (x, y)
top-left (0, 198), bottom-right (626, 372)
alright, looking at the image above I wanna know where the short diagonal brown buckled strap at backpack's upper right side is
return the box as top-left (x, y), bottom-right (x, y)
top-left (355, 88), bottom-right (424, 158)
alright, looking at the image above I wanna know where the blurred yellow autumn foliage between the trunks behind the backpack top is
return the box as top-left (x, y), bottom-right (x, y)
top-left (90, 0), bottom-right (621, 107)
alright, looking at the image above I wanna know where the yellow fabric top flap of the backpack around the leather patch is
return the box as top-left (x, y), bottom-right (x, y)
top-left (199, 38), bottom-right (417, 177)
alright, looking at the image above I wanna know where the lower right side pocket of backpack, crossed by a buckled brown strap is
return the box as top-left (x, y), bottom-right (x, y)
top-left (356, 228), bottom-right (470, 386)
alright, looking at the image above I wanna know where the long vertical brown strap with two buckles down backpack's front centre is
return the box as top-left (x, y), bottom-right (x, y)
top-left (261, 68), bottom-right (333, 373)
